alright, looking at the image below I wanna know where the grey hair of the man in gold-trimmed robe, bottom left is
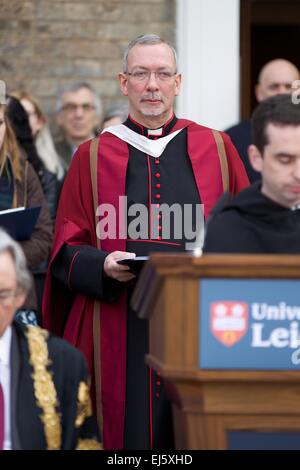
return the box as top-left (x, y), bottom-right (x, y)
top-left (0, 228), bottom-right (31, 293)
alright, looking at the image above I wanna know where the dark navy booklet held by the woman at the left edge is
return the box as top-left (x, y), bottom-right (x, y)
top-left (0, 206), bottom-right (41, 241)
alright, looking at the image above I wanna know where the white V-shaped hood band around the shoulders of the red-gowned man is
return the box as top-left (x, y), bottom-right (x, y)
top-left (101, 124), bottom-right (182, 158)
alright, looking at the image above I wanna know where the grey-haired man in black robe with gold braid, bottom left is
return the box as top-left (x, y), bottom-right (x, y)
top-left (0, 229), bottom-right (101, 450)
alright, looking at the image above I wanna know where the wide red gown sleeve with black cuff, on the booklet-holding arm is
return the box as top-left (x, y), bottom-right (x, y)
top-left (43, 141), bottom-right (124, 334)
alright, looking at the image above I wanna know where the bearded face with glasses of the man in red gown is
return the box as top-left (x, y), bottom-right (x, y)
top-left (119, 44), bottom-right (181, 125)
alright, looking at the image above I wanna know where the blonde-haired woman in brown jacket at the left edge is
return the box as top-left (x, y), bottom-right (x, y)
top-left (0, 104), bottom-right (52, 324)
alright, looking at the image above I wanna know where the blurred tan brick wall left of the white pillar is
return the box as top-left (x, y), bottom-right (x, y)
top-left (0, 0), bottom-right (176, 125)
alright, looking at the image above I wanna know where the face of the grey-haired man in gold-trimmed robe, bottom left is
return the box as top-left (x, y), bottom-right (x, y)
top-left (0, 251), bottom-right (25, 336)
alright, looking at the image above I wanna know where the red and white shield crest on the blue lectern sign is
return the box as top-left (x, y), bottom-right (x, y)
top-left (210, 301), bottom-right (248, 347)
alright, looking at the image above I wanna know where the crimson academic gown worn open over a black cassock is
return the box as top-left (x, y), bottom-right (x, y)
top-left (43, 120), bottom-right (248, 449)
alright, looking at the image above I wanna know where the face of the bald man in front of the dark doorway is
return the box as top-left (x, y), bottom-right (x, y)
top-left (256, 59), bottom-right (299, 102)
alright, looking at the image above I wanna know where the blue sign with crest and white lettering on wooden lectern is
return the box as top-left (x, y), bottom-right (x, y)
top-left (199, 279), bottom-right (300, 370)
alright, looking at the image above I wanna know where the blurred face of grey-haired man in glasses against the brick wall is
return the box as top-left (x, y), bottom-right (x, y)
top-left (57, 88), bottom-right (99, 143)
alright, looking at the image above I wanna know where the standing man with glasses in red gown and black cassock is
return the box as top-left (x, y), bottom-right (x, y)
top-left (44, 35), bottom-right (248, 449)
